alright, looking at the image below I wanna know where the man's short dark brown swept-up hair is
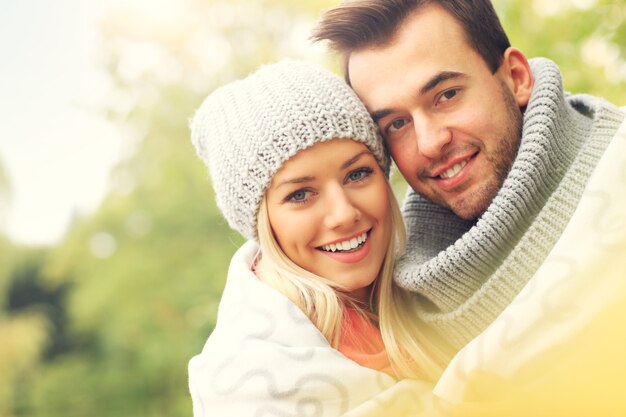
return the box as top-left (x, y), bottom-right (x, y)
top-left (311, 0), bottom-right (511, 79)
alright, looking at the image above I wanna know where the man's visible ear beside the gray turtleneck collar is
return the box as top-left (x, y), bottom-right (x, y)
top-left (498, 47), bottom-right (534, 108)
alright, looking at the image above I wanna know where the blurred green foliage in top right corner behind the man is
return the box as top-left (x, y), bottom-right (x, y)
top-left (494, 0), bottom-right (626, 106)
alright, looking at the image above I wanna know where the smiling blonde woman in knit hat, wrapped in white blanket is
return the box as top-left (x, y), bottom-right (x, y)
top-left (189, 61), bottom-right (447, 417)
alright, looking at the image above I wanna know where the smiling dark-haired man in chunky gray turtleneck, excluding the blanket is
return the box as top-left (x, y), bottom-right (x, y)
top-left (314, 0), bottom-right (624, 346)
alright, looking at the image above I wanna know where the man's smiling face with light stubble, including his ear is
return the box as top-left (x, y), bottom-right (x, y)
top-left (348, 5), bottom-right (532, 219)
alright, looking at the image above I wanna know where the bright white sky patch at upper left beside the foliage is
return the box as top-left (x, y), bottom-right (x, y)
top-left (0, 0), bottom-right (124, 245)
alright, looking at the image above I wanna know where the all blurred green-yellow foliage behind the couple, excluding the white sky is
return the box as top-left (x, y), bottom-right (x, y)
top-left (0, 0), bottom-right (626, 417)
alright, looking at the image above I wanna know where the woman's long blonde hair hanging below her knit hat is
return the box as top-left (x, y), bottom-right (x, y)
top-left (257, 183), bottom-right (451, 381)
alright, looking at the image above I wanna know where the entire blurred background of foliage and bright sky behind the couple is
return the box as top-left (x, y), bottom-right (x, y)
top-left (0, 0), bottom-right (626, 417)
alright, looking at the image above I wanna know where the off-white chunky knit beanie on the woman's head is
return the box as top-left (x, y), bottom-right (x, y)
top-left (191, 61), bottom-right (389, 239)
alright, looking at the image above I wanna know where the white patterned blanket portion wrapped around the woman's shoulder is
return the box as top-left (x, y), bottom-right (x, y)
top-left (189, 242), bottom-right (402, 417)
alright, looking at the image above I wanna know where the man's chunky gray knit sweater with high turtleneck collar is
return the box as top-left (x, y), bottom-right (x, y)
top-left (396, 58), bottom-right (624, 347)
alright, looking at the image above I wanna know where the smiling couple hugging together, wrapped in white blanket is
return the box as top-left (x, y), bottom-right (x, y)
top-left (189, 0), bottom-right (626, 417)
